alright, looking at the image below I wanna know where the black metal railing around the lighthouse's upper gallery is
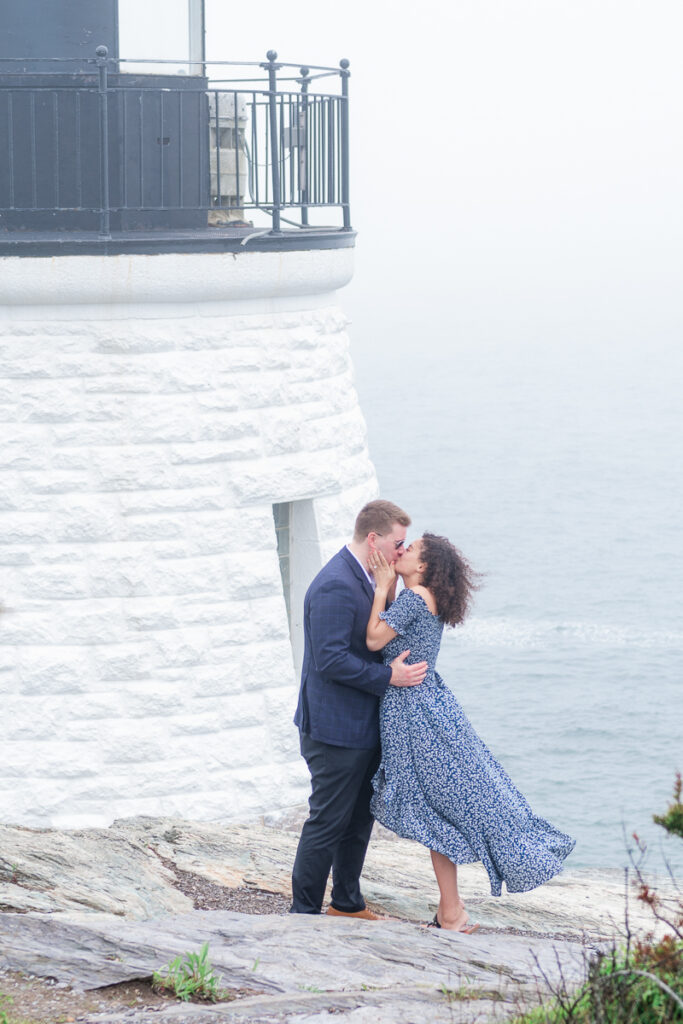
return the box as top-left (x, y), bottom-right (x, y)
top-left (0, 46), bottom-right (351, 238)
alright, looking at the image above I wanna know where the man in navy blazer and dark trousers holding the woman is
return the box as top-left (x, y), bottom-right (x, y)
top-left (291, 501), bottom-right (427, 921)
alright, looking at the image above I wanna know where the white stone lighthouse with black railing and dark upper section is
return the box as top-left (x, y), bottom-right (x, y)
top-left (0, 0), bottom-right (377, 827)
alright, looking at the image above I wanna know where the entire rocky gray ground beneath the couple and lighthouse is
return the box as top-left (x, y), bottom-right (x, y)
top-left (0, 818), bottom-right (671, 1024)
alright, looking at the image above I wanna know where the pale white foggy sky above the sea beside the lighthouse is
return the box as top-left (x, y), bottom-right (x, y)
top-left (121, 0), bottom-right (683, 344)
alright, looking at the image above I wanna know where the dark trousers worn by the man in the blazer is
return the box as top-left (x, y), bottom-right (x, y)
top-left (291, 732), bottom-right (380, 913)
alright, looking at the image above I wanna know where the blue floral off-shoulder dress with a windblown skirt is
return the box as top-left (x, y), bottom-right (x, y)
top-left (371, 590), bottom-right (574, 896)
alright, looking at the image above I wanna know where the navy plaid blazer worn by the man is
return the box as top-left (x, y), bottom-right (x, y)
top-left (294, 547), bottom-right (391, 750)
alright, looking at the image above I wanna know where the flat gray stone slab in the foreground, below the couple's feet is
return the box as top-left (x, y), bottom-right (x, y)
top-left (0, 910), bottom-right (584, 1021)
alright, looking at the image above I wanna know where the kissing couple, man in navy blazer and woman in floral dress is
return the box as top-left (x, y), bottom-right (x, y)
top-left (291, 501), bottom-right (574, 933)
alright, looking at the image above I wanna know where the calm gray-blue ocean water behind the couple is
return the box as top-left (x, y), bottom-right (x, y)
top-left (352, 327), bottom-right (683, 874)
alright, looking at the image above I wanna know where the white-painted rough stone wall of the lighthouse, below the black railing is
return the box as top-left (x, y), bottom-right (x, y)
top-left (0, 250), bottom-right (377, 826)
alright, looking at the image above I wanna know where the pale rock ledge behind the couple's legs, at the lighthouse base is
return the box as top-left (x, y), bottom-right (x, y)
top-left (0, 818), bottom-right (666, 937)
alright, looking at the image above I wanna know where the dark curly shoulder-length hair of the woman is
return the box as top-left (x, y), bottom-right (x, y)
top-left (420, 534), bottom-right (481, 626)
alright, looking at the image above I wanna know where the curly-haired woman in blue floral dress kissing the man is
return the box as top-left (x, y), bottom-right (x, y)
top-left (367, 534), bottom-right (574, 933)
